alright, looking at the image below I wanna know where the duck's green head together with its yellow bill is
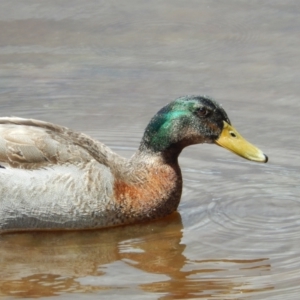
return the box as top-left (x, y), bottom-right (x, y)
top-left (139, 96), bottom-right (268, 162)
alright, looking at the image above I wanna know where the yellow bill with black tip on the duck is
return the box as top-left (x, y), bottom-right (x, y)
top-left (215, 121), bottom-right (268, 163)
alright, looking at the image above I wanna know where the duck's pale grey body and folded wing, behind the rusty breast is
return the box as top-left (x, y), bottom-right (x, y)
top-left (0, 118), bottom-right (127, 230)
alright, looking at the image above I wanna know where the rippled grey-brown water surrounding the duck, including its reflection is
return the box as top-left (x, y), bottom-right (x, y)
top-left (0, 0), bottom-right (300, 299)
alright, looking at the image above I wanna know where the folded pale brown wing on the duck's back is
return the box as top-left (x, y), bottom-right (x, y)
top-left (0, 117), bottom-right (122, 170)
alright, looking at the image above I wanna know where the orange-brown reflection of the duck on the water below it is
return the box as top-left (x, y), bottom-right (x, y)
top-left (0, 213), bottom-right (271, 299)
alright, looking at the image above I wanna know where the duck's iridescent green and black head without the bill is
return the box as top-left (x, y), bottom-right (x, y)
top-left (140, 96), bottom-right (230, 152)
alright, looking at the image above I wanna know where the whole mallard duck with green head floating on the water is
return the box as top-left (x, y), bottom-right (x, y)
top-left (0, 96), bottom-right (268, 231)
